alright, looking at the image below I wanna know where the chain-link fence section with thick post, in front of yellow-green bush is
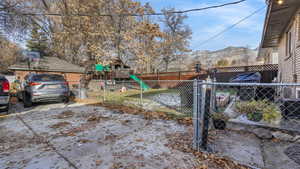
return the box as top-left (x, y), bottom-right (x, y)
top-left (193, 81), bottom-right (300, 150)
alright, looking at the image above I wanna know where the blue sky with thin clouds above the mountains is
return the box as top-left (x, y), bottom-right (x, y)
top-left (140, 0), bottom-right (266, 50)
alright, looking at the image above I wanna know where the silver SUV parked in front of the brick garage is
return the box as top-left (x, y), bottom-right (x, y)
top-left (18, 74), bottom-right (70, 107)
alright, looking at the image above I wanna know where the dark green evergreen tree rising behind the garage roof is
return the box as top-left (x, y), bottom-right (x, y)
top-left (26, 25), bottom-right (48, 57)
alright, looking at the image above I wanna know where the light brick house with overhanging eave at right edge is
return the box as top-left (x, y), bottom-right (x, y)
top-left (259, 0), bottom-right (300, 85)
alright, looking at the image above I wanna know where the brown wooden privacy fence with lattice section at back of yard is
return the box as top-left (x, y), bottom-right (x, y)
top-left (136, 64), bottom-right (278, 87)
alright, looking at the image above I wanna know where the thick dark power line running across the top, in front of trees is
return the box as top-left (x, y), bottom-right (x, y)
top-left (2, 0), bottom-right (246, 17)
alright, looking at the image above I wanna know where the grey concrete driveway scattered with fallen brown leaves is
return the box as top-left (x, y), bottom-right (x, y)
top-left (0, 101), bottom-right (199, 169)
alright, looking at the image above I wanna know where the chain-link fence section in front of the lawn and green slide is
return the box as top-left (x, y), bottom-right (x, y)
top-left (69, 80), bottom-right (193, 117)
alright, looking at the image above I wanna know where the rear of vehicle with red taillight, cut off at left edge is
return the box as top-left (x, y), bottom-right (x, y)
top-left (0, 75), bottom-right (10, 111)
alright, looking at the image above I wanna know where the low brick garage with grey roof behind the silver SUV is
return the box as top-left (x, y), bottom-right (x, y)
top-left (9, 57), bottom-right (84, 84)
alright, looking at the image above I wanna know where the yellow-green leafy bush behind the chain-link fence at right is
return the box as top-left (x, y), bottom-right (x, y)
top-left (235, 100), bottom-right (281, 123)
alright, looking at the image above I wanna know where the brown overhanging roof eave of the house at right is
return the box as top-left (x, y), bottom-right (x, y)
top-left (261, 0), bottom-right (300, 48)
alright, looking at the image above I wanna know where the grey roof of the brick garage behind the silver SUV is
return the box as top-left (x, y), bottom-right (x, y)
top-left (9, 57), bottom-right (84, 73)
